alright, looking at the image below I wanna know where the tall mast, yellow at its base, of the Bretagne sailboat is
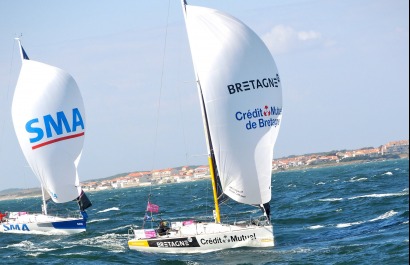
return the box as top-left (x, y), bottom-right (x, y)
top-left (181, 0), bottom-right (221, 223)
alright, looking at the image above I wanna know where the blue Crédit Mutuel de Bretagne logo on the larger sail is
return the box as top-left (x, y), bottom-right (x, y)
top-left (235, 105), bottom-right (282, 130)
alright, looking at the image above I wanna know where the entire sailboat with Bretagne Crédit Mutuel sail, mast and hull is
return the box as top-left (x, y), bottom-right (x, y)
top-left (128, 1), bottom-right (282, 253)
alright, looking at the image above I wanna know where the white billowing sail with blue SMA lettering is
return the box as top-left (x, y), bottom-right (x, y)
top-left (12, 41), bottom-right (85, 203)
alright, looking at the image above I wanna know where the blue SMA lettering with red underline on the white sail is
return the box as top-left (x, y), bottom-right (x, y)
top-left (26, 108), bottom-right (84, 150)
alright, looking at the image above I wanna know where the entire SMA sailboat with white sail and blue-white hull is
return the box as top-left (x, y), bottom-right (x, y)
top-left (0, 39), bottom-right (91, 234)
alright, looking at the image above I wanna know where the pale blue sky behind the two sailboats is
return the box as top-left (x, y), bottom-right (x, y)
top-left (0, 0), bottom-right (409, 190)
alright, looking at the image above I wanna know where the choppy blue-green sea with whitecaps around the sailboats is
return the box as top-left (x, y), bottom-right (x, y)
top-left (0, 159), bottom-right (409, 265)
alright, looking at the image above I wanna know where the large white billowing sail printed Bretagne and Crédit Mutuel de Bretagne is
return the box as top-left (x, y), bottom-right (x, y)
top-left (185, 5), bottom-right (282, 204)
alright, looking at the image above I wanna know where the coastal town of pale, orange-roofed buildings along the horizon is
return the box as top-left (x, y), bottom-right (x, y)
top-left (78, 140), bottom-right (409, 191)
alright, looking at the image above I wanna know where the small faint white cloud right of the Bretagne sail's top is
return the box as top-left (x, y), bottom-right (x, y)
top-left (262, 25), bottom-right (325, 54)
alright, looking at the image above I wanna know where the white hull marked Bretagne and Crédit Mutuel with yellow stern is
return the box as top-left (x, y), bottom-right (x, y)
top-left (128, 223), bottom-right (274, 253)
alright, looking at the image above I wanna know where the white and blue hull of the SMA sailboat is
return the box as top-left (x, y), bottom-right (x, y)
top-left (0, 213), bottom-right (86, 235)
